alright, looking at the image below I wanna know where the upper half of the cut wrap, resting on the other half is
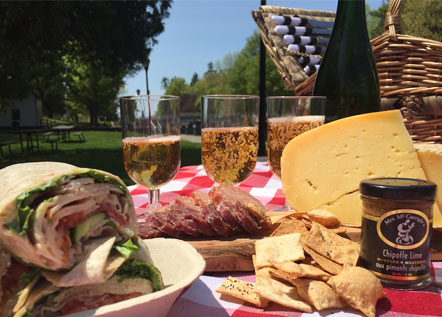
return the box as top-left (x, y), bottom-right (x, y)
top-left (0, 162), bottom-right (138, 270)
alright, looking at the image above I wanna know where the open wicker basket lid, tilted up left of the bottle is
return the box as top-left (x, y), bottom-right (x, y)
top-left (252, 6), bottom-right (336, 90)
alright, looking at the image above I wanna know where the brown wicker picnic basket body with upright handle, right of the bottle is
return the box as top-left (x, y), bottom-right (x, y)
top-left (295, 0), bottom-right (442, 143)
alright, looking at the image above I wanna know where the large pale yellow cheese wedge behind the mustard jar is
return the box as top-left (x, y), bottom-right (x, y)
top-left (281, 110), bottom-right (442, 227)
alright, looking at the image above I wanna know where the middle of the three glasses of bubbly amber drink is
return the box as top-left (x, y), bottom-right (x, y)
top-left (201, 95), bottom-right (259, 185)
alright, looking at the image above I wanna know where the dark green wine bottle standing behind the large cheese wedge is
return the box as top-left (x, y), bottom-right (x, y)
top-left (313, 0), bottom-right (380, 122)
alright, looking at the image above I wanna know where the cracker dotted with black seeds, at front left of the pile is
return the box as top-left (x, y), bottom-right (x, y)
top-left (216, 276), bottom-right (269, 307)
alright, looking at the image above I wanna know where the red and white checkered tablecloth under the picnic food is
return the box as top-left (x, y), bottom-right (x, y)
top-left (129, 162), bottom-right (442, 317)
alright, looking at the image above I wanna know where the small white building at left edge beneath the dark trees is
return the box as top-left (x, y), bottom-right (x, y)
top-left (0, 94), bottom-right (43, 128)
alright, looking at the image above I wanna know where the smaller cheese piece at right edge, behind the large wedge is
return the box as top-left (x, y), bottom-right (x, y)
top-left (414, 143), bottom-right (442, 227)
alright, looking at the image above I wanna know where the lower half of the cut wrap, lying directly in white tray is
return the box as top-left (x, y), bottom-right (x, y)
top-left (10, 240), bottom-right (164, 317)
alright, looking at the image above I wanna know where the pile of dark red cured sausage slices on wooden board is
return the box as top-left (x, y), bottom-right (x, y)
top-left (139, 185), bottom-right (270, 239)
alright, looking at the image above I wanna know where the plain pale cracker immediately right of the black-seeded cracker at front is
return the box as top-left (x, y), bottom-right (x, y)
top-left (255, 268), bottom-right (312, 313)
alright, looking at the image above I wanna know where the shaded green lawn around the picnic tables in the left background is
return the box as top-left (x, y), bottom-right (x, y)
top-left (0, 131), bottom-right (201, 185)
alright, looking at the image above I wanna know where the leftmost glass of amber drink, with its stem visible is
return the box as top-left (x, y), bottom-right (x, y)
top-left (120, 95), bottom-right (181, 211)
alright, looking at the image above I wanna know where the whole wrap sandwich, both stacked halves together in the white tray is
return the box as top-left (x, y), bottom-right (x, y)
top-left (0, 162), bottom-right (163, 317)
